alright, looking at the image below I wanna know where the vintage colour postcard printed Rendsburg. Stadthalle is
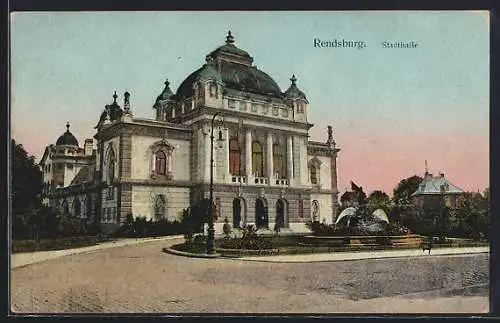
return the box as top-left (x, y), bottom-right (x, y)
top-left (9, 11), bottom-right (490, 315)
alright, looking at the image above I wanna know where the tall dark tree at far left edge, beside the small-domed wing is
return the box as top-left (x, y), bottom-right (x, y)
top-left (10, 139), bottom-right (42, 240)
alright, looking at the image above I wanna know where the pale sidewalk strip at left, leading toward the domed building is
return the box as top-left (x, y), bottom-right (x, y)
top-left (10, 235), bottom-right (184, 269)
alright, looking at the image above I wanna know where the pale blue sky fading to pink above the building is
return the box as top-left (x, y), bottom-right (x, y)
top-left (11, 11), bottom-right (489, 195)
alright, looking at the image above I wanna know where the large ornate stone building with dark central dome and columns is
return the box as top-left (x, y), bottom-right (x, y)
top-left (41, 32), bottom-right (339, 232)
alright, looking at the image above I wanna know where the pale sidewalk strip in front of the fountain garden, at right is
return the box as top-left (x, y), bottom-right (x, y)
top-left (235, 247), bottom-right (490, 262)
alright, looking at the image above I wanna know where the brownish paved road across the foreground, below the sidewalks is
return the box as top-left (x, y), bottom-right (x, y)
top-left (11, 240), bottom-right (489, 313)
